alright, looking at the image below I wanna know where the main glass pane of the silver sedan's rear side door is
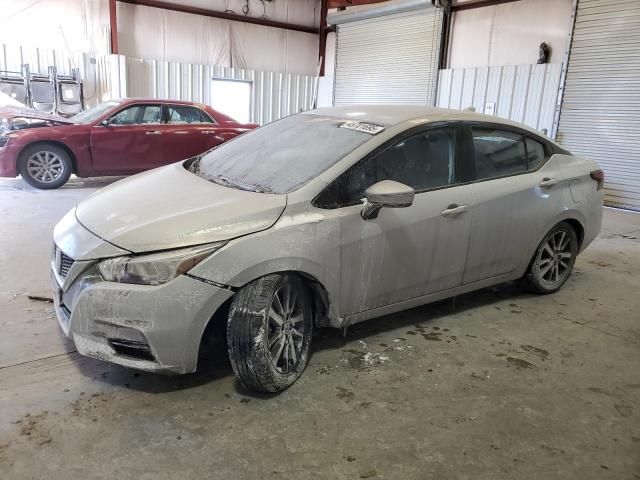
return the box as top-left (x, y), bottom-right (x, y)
top-left (473, 127), bottom-right (527, 180)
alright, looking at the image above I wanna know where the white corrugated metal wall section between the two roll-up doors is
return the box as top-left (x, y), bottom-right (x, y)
top-left (437, 63), bottom-right (562, 134)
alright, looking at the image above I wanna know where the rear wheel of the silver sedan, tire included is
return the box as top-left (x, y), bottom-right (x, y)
top-left (525, 222), bottom-right (578, 293)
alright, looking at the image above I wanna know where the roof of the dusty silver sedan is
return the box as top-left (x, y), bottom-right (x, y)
top-left (307, 105), bottom-right (541, 135)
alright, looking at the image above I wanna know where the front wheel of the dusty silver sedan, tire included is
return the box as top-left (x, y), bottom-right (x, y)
top-left (227, 273), bottom-right (313, 392)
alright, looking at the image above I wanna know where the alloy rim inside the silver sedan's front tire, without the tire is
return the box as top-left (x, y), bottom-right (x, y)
top-left (267, 284), bottom-right (305, 374)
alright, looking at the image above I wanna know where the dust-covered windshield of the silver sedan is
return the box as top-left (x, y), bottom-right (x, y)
top-left (189, 114), bottom-right (378, 193)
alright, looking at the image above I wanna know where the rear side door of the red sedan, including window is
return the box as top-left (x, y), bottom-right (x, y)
top-left (165, 104), bottom-right (225, 163)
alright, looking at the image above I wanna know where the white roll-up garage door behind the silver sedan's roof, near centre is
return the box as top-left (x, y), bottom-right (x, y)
top-left (334, 6), bottom-right (442, 106)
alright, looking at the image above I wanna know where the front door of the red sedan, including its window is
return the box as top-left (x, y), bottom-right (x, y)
top-left (91, 103), bottom-right (166, 175)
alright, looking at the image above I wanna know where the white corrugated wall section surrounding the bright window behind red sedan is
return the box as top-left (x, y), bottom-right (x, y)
top-left (122, 55), bottom-right (316, 125)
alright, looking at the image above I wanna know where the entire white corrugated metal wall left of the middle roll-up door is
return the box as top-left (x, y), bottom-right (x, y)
top-left (0, 45), bottom-right (316, 125)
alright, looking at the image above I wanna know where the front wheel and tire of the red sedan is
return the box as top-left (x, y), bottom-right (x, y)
top-left (18, 144), bottom-right (72, 189)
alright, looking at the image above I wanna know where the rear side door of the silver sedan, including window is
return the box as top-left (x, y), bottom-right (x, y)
top-left (464, 124), bottom-right (562, 284)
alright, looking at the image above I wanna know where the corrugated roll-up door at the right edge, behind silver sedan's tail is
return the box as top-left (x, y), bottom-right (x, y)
top-left (557, 0), bottom-right (640, 210)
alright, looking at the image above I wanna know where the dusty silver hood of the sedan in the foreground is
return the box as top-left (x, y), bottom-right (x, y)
top-left (76, 163), bottom-right (287, 253)
